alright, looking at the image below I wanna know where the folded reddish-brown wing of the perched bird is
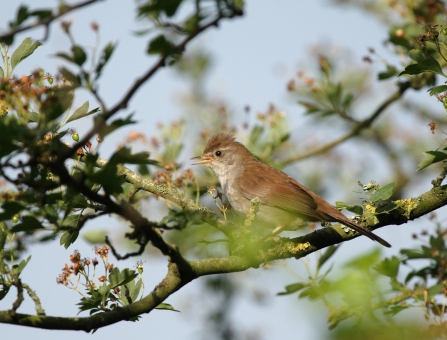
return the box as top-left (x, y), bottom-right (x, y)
top-left (238, 165), bottom-right (321, 220)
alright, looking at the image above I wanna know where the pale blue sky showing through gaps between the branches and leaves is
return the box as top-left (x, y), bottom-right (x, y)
top-left (1, 0), bottom-right (441, 339)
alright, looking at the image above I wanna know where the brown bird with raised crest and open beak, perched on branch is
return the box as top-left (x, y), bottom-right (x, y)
top-left (192, 133), bottom-right (391, 247)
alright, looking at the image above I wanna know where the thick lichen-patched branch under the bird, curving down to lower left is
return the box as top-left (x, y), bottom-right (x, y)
top-left (0, 171), bottom-right (447, 331)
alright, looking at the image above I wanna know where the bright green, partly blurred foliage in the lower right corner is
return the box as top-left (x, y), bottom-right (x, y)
top-left (279, 222), bottom-right (447, 339)
